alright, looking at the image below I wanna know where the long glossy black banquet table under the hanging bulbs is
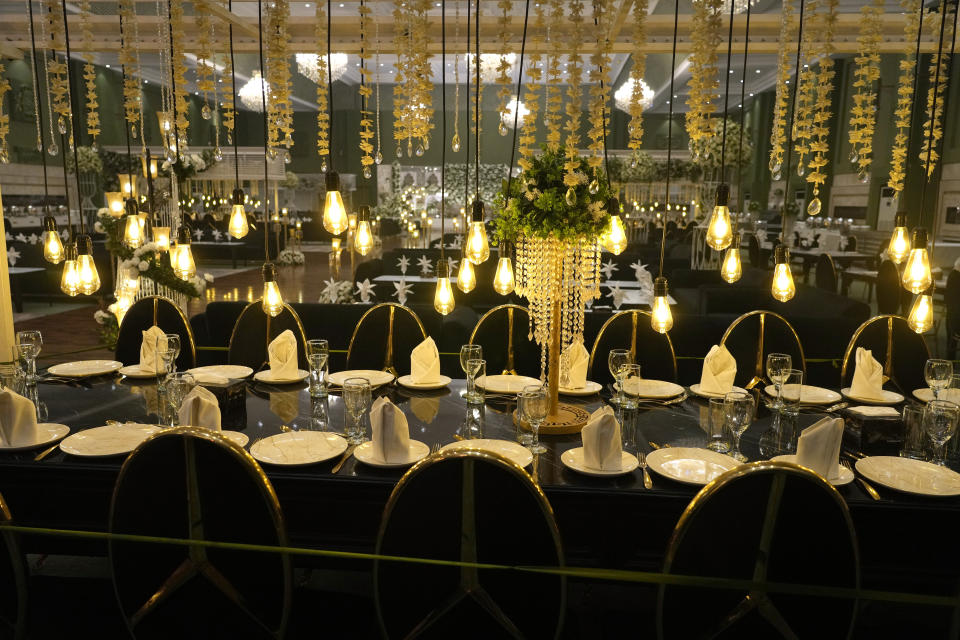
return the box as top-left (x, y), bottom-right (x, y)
top-left (0, 378), bottom-right (960, 593)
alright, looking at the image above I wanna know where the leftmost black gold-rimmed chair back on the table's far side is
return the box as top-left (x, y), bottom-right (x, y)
top-left (114, 296), bottom-right (197, 371)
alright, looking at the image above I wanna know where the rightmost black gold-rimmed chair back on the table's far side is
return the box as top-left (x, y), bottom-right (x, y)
top-left (840, 315), bottom-right (930, 396)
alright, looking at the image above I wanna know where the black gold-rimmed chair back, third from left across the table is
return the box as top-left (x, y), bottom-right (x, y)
top-left (347, 302), bottom-right (427, 375)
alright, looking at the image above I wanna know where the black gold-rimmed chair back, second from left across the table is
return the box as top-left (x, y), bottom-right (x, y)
top-left (227, 300), bottom-right (307, 371)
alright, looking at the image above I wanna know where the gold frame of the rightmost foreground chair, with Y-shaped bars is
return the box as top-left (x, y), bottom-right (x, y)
top-left (657, 460), bottom-right (860, 639)
